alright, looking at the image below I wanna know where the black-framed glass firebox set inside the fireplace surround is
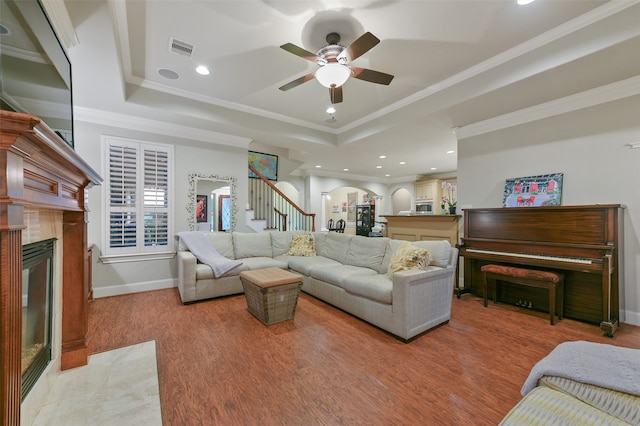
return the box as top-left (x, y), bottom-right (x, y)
top-left (21, 238), bottom-right (55, 400)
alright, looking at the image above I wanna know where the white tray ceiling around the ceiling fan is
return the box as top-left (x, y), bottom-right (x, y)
top-left (66, 0), bottom-right (640, 182)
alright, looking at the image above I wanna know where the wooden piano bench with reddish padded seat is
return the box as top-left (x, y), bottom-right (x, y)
top-left (480, 265), bottom-right (564, 325)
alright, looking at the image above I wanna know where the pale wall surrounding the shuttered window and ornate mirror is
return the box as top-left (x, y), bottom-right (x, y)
top-left (75, 121), bottom-right (248, 297)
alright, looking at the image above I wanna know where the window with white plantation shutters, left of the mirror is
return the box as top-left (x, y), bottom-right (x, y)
top-left (103, 137), bottom-right (173, 256)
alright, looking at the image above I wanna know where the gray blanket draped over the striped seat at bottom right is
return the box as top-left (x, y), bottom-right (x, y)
top-left (520, 341), bottom-right (640, 396)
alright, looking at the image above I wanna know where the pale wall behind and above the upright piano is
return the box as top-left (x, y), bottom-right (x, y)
top-left (458, 96), bottom-right (640, 325)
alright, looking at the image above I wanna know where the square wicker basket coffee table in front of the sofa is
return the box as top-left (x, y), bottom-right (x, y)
top-left (240, 268), bottom-right (302, 325)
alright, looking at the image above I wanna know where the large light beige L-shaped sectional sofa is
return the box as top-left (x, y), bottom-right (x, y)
top-left (177, 231), bottom-right (458, 341)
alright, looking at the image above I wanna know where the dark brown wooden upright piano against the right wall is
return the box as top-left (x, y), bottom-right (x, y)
top-left (458, 204), bottom-right (624, 337)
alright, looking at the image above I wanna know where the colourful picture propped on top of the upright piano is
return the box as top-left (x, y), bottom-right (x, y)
top-left (502, 173), bottom-right (563, 207)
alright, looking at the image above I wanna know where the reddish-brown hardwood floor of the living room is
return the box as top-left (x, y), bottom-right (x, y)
top-left (89, 289), bottom-right (640, 426)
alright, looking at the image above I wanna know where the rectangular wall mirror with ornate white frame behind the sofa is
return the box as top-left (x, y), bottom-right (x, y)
top-left (187, 173), bottom-right (238, 231)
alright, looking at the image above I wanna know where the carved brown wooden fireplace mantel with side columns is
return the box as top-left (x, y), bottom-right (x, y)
top-left (0, 110), bottom-right (102, 426)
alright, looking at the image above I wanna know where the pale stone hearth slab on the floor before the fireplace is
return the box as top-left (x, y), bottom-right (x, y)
top-left (34, 340), bottom-right (162, 426)
